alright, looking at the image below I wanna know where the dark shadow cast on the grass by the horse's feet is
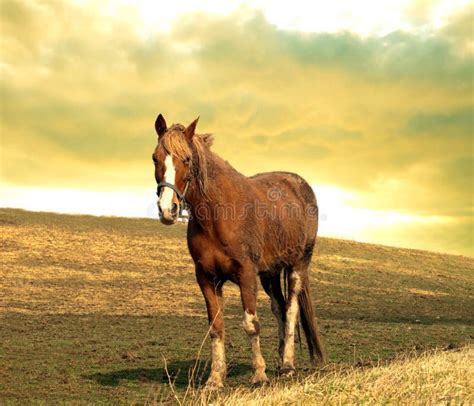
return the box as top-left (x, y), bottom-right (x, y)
top-left (83, 359), bottom-right (252, 389)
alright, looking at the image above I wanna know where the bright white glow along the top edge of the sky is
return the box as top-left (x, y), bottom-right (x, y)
top-left (69, 0), bottom-right (470, 36)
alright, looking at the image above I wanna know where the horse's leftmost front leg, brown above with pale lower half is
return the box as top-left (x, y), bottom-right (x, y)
top-left (196, 267), bottom-right (226, 389)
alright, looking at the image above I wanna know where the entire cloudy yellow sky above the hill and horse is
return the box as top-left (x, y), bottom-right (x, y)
top-left (0, 0), bottom-right (474, 256)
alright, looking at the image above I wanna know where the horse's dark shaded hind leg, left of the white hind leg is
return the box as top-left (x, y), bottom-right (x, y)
top-left (260, 271), bottom-right (286, 365)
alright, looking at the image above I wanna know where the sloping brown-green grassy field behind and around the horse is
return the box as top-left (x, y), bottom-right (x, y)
top-left (0, 209), bottom-right (474, 404)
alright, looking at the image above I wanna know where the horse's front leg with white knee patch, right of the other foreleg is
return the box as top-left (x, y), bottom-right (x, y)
top-left (239, 268), bottom-right (268, 385)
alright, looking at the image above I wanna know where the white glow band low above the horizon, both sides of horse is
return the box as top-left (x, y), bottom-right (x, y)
top-left (0, 185), bottom-right (451, 252)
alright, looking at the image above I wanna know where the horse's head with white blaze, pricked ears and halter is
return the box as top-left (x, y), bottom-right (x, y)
top-left (152, 114), bottom-right (199, 225)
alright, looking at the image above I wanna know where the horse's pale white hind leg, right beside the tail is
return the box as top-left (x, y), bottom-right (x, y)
top-left (280, 268), bottom-right (301, 375)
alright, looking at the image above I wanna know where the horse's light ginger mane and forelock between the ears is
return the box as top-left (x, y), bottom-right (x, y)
top-left (160, 124), bottom-right (214, 198)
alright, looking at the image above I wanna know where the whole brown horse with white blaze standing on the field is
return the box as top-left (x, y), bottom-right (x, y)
top-left (152, 114), bottom-right (325, 388)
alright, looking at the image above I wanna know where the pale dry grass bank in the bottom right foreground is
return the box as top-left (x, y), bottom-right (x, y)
top-left (194, 346), bottom-right (474, 406)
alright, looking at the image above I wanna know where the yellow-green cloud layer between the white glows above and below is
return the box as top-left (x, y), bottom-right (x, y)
top-left (0, 0), bottom-right (474, 254)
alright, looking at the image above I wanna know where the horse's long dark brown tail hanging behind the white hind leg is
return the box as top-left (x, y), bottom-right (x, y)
top-left (298, 276), bottom-right (327, 365)
